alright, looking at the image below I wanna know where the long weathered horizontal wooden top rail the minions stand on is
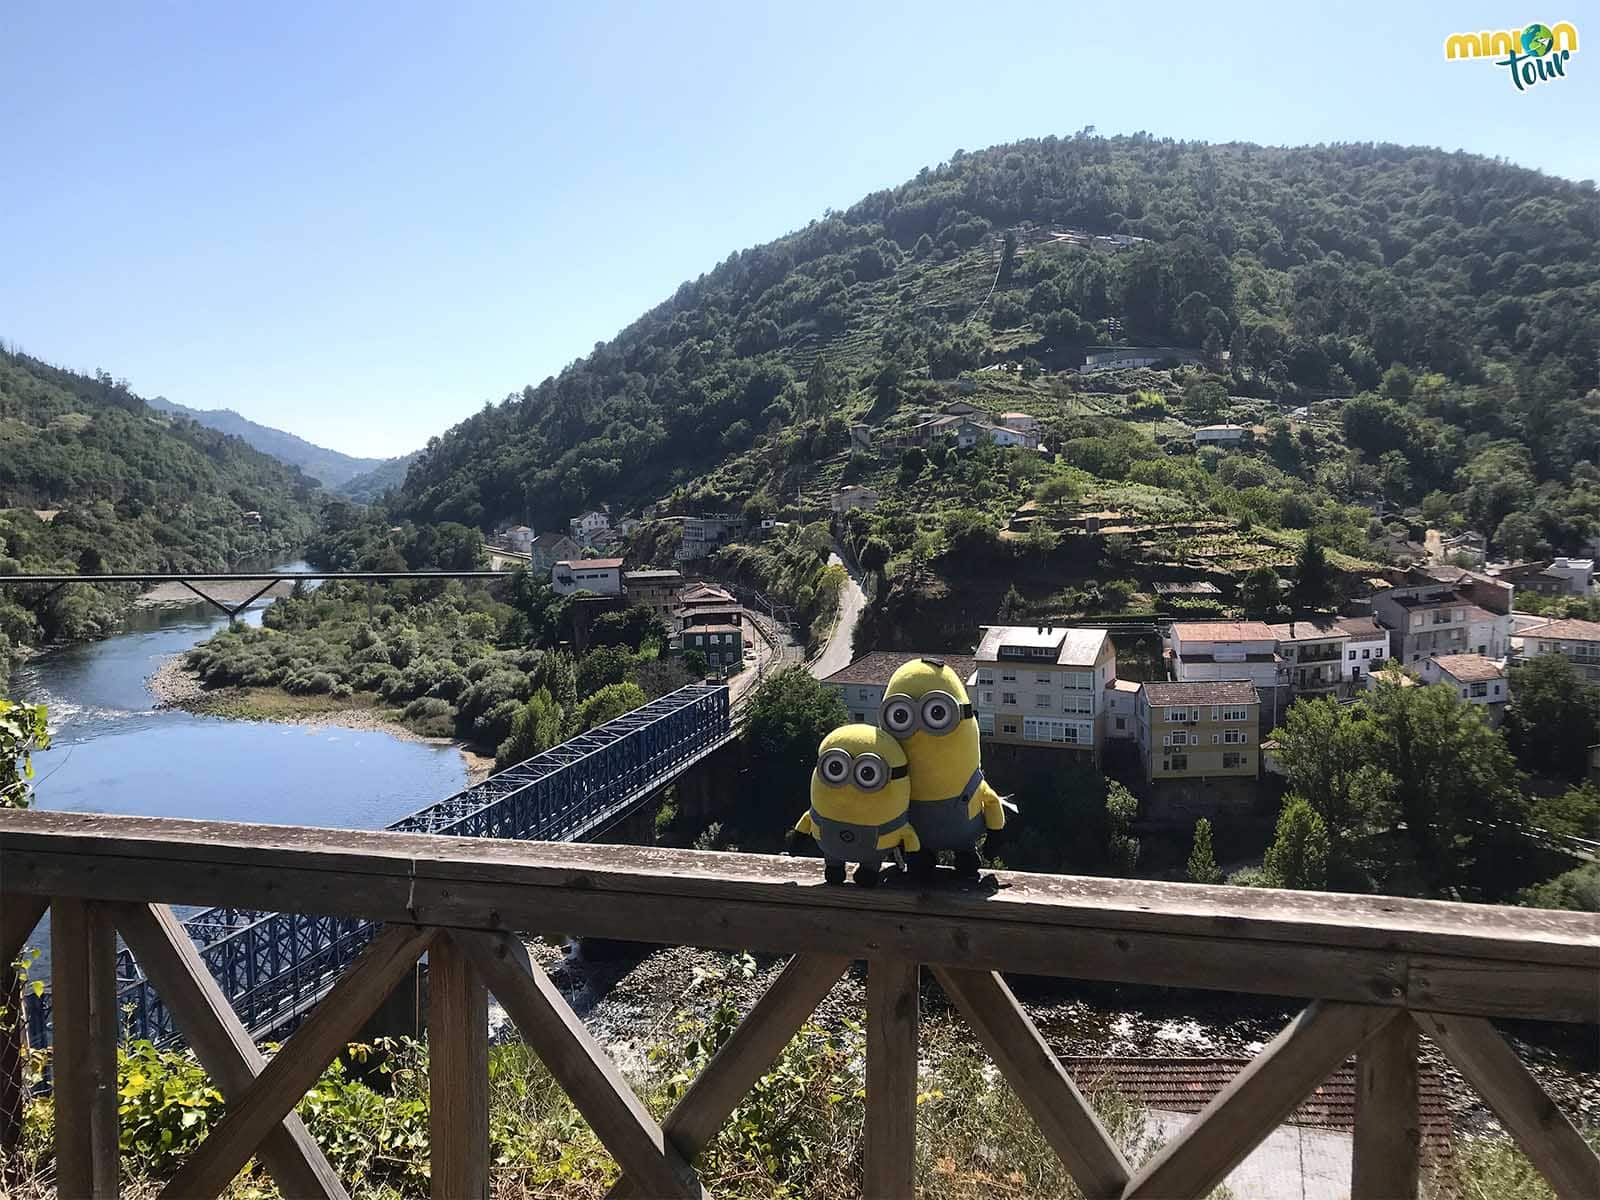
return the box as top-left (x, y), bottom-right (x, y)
top-left (0, 811), bottom-right (1600, 1021)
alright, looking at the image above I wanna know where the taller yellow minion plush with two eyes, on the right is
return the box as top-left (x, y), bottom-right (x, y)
top-left (878, 658), bottom-right (1005, 878)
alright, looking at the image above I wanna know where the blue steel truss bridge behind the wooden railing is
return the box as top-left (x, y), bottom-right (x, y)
top-left (27, 683), bottom-right (734, 1046)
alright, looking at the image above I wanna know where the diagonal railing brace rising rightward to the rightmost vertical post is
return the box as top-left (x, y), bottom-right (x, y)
top-left (1123, 1000), bottom-right (1395, 1200)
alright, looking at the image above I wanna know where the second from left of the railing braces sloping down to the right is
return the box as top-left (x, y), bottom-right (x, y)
top-left (451, 930), bottom-right (706, 1197)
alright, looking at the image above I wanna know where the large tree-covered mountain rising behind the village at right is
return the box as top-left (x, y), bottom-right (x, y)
top-left (402, 134), bottom-right (1600, 538)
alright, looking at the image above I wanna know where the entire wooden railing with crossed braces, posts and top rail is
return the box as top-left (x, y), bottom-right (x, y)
top-left (0, 813), bottom-right (1600, 1200)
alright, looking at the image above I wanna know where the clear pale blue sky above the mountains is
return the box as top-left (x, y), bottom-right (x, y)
top-left (0, 0), bottom-right (1600, 454)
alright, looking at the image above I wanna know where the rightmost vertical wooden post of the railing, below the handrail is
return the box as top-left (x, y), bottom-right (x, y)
top-left (1350, 1016), bottom-right (1422, 1200)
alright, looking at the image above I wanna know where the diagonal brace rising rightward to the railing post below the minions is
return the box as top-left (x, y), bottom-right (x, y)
top-left (606, 954), bottom-right (850, 1200)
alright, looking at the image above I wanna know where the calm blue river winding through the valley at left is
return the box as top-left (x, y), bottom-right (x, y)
top-left (11, 562), bottom-right (467, 829)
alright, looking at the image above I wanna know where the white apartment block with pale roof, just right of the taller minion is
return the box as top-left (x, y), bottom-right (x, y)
top-left (968, 626), bottom-right (1117, 763)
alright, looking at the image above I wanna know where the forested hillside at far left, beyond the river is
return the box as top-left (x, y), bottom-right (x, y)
top-left (0, 349), bottom-right (317, 658)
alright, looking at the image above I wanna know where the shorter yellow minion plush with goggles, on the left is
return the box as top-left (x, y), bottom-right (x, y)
top-left (795, 725), bottom-right (918, 888)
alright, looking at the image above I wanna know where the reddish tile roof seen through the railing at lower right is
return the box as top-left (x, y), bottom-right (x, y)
top-left (1061, 1058), bottom-right (1451, 1155)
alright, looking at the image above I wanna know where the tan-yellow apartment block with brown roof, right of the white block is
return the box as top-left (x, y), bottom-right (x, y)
top-left (1138, 680), bottom-right (1261, 782)
